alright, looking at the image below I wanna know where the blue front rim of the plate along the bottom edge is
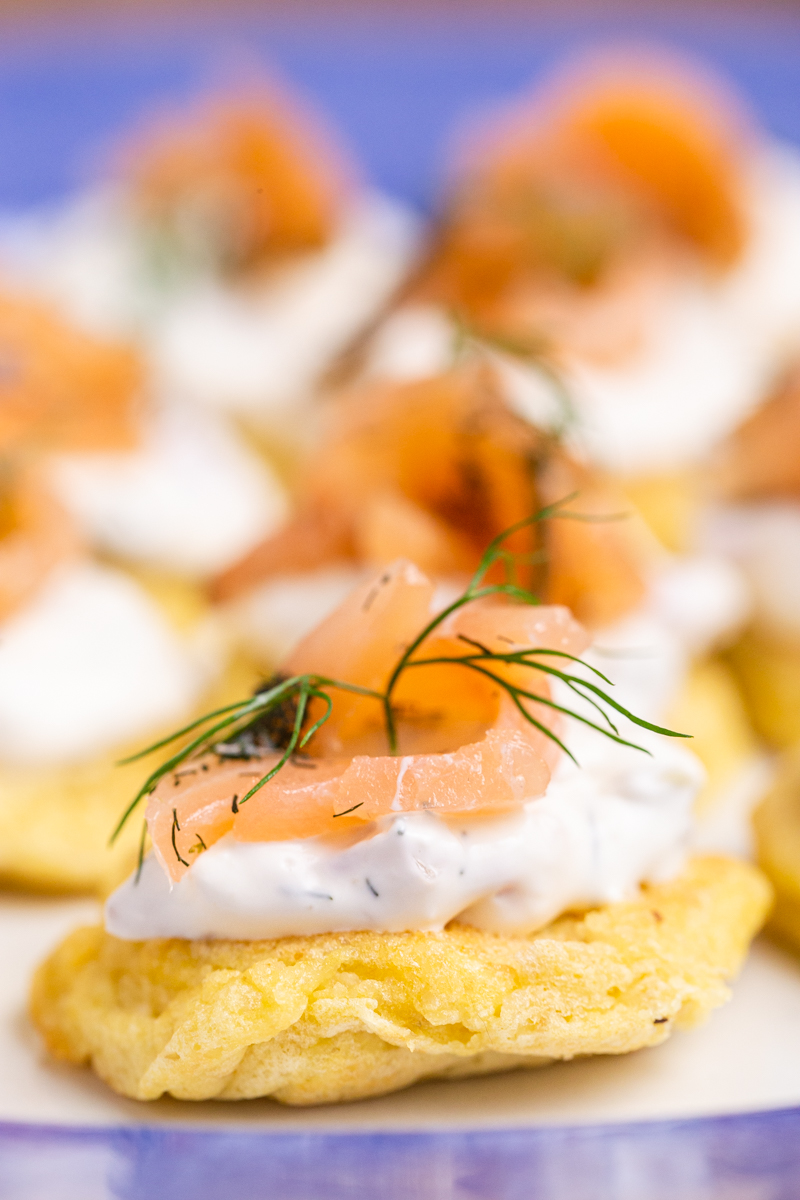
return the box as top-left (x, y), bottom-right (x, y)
top-left (0, 1108), bottom-right (800, 1200)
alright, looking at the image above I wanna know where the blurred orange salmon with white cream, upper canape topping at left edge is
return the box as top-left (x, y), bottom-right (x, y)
top-left (0, 292), bottom-right (285, 599)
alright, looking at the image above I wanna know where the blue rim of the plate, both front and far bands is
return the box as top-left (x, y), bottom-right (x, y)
top-left (0, 0), bottom-right (800, 1200)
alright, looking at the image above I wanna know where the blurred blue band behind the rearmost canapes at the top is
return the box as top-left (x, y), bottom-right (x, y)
top-left (0, 5), bottom-right (800, 209)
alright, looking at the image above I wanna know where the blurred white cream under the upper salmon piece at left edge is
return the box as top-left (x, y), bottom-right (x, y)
top-left (54, 404), bottom-right (287, 576)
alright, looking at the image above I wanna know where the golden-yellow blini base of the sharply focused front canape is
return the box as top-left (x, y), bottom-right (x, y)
top-left (31, 858), bottom-right (770, 1104)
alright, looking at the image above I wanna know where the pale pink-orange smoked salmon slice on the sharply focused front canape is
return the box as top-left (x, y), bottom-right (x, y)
top-left (146, 560), bottom-right (589, 880)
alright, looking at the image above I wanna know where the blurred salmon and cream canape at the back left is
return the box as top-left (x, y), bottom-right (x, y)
top-left (0, 82), bottom-right (419, 454)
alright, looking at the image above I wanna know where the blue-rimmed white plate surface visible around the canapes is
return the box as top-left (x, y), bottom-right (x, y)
top-left (0, 8), bottom-right (800, 1200)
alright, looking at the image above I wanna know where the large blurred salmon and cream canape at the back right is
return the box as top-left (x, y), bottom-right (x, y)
top-left (371, 50), bottom-right (800, 548)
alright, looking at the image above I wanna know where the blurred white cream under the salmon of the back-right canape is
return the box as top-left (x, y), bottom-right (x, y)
top-left (367, 289), bottom-right (771, 474)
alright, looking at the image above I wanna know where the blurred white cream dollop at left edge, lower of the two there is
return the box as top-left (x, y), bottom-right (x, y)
top-left (0, 563), bottom-right (216, 766)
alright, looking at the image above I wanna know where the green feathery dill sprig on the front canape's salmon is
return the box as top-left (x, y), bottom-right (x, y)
top-left (110, 493), bottom-right (690, 857)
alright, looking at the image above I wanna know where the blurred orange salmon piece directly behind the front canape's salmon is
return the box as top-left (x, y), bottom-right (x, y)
top-left (212, 364), bottom-right (644, 624)
